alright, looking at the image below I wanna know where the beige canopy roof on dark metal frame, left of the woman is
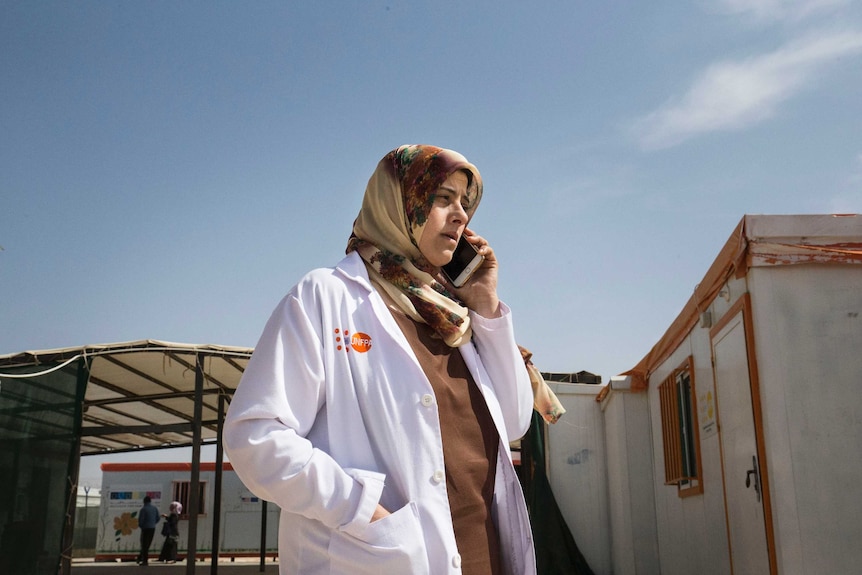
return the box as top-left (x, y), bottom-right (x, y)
top-left (0, 340), bottom-right (253, 455)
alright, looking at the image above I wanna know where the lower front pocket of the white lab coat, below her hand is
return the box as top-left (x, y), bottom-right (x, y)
top-left (329, 501), bottom-right (430, 575)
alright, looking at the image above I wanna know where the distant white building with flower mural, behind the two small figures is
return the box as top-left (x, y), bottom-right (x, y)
top-left (95, 463), bottom-right (280, 561)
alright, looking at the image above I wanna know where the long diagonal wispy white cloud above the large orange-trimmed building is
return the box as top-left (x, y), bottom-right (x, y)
top-left (633, 32), bottom-right (862, 149)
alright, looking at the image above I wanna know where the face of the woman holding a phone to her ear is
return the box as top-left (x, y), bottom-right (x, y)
top-left (419, 170), bottom-right (468, 268)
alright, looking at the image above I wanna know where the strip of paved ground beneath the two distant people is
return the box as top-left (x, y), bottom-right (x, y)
top-left (72, 558), bottom-right (278, 575)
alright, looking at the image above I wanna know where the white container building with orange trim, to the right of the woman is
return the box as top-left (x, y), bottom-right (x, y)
top-left (548, 215), bottom-right (862, 575)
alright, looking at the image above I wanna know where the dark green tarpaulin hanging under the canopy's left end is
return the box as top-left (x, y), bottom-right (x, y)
top-left (0, 361), bottom-right (86, 575)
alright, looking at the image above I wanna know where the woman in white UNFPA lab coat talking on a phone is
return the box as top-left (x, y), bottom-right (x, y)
top-left (224, 145), bottom-right (535, 575)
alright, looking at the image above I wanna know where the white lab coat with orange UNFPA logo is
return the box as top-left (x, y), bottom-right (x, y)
top-left (224, 252), bottom-right (536, 575)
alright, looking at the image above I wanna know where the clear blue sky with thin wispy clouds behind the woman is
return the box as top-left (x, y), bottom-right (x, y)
top-left (5, 0), bottom-right (862, 486)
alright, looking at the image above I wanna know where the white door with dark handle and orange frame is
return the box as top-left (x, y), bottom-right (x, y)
top-left (712, 310), bottom-right (770, 575)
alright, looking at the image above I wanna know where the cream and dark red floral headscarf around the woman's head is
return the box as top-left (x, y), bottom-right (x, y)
top-left (347, 145), bottom-right (482, 347)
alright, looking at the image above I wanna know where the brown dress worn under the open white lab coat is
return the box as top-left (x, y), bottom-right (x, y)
top-left (384, 304), bottom-right (502, 575)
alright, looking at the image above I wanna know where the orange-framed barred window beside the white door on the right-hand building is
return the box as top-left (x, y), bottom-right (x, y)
top-left (658, 356), bottom-right (703, 497)
